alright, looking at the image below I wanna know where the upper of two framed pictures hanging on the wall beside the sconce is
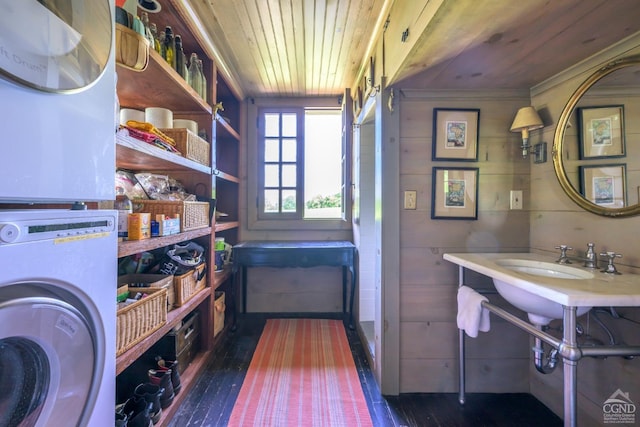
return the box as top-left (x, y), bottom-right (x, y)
top-left (431, 108), bottom-right (480, 162)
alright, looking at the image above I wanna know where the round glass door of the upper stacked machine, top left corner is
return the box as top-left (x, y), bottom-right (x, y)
top-left (0, 0), bottom-right (113, 92)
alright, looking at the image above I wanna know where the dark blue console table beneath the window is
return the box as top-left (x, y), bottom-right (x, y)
top-left (233, 241), bottom-right (357, 327)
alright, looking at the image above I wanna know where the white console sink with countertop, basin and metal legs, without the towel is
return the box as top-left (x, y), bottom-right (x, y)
top-left (443, 253), bottom-right (640, 425)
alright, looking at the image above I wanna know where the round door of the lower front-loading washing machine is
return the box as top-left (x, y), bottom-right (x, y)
top-left (0, 292), bottom-right (99, 426)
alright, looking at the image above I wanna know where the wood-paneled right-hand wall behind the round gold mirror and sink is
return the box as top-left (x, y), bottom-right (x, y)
top-left (530, 39), bottom-right (640, 425)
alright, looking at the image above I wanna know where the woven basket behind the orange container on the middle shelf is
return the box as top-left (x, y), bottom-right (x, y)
top-left (133, 200), bottom-right (209, 231)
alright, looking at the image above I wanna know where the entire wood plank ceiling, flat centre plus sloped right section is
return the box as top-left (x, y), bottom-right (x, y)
top-left (190, 0), bottom-right (640, 97)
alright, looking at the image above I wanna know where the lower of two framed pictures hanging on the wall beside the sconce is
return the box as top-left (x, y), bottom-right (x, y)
top-left (431, 167), bottom-right (479, 220)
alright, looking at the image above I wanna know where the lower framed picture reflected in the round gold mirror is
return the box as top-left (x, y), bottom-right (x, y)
top-left (580, 163), bottom-right (627, 208)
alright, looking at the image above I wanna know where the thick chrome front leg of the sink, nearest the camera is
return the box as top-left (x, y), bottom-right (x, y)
top-left (561, 306), bottom-right (580, 427)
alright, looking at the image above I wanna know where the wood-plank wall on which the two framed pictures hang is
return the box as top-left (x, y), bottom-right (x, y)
top-left (399, 88), bottom-right (530, 393)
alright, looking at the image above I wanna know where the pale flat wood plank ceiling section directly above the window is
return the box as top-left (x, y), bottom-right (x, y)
top-left (200, 0), bottom-right (383, 96)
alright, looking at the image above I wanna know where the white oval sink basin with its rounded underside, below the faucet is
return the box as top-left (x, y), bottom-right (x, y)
top-left (493, 258), bottom-right (593, 326)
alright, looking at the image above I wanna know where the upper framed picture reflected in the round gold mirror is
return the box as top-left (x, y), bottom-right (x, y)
top-left (578, 105), bottom-right (625, 159)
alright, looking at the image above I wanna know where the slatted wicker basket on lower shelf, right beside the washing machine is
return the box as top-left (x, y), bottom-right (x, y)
top-left (116, 288), bottom-right (167, 356)
